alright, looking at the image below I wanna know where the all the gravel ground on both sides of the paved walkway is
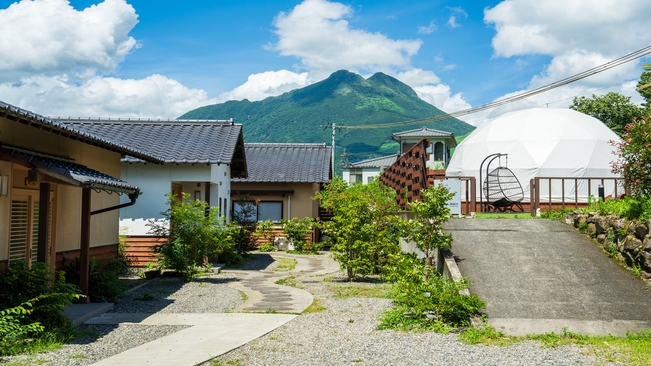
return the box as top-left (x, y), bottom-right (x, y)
top-left (0, 255), bottom-right (603, 366)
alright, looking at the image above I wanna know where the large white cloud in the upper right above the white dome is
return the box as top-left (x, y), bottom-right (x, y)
top-left (484, 0), bottom-right (651, 123)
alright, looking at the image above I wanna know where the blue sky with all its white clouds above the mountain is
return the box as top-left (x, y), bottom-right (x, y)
top-left (0, 0), bottom-right (651, 125)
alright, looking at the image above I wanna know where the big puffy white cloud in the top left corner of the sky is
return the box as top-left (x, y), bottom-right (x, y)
top-left (0, 0), bottom-right (138, 81)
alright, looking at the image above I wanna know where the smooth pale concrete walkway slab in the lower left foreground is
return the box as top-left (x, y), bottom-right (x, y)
top-left (87, 314), bottom-right (296, 366)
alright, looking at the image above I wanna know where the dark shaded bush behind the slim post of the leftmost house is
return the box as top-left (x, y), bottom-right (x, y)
top-left (64, 257), bottom-right (129, 302)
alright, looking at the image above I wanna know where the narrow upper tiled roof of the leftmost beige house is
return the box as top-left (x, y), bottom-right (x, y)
top-left (0, 101), bottom-right (161, 163)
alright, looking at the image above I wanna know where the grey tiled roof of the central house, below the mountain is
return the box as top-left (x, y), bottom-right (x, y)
top-left (233, 143), bottom-right (332, 183)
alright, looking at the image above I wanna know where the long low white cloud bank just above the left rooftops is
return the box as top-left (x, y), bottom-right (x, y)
top-left (0, 74), bottom-right (217, 118)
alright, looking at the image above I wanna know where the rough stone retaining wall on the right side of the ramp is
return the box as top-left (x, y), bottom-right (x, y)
top-left (565, 211), bottom-right (651, 280)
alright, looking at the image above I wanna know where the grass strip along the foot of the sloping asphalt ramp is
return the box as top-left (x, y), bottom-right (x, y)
top-left (459, 326), bottom-right (651, 365)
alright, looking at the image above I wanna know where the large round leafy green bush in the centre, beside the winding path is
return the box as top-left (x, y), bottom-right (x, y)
top-left (315, 178), bottom-right (400, 280)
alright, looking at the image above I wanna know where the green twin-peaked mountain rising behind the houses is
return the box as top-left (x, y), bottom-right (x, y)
top-left (179, 70), bottom-right (474, 162)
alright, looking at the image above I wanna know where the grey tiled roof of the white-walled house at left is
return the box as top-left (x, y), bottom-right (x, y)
top-left (59, 118), bottom-right (242, 164)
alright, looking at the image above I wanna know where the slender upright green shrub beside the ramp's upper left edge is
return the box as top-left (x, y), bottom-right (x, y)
top-left (403, 184), bottom-right (454, 277)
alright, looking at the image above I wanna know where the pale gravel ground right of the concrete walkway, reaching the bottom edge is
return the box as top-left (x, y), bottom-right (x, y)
top-left (210, 276), bottom-right (604, 366)
